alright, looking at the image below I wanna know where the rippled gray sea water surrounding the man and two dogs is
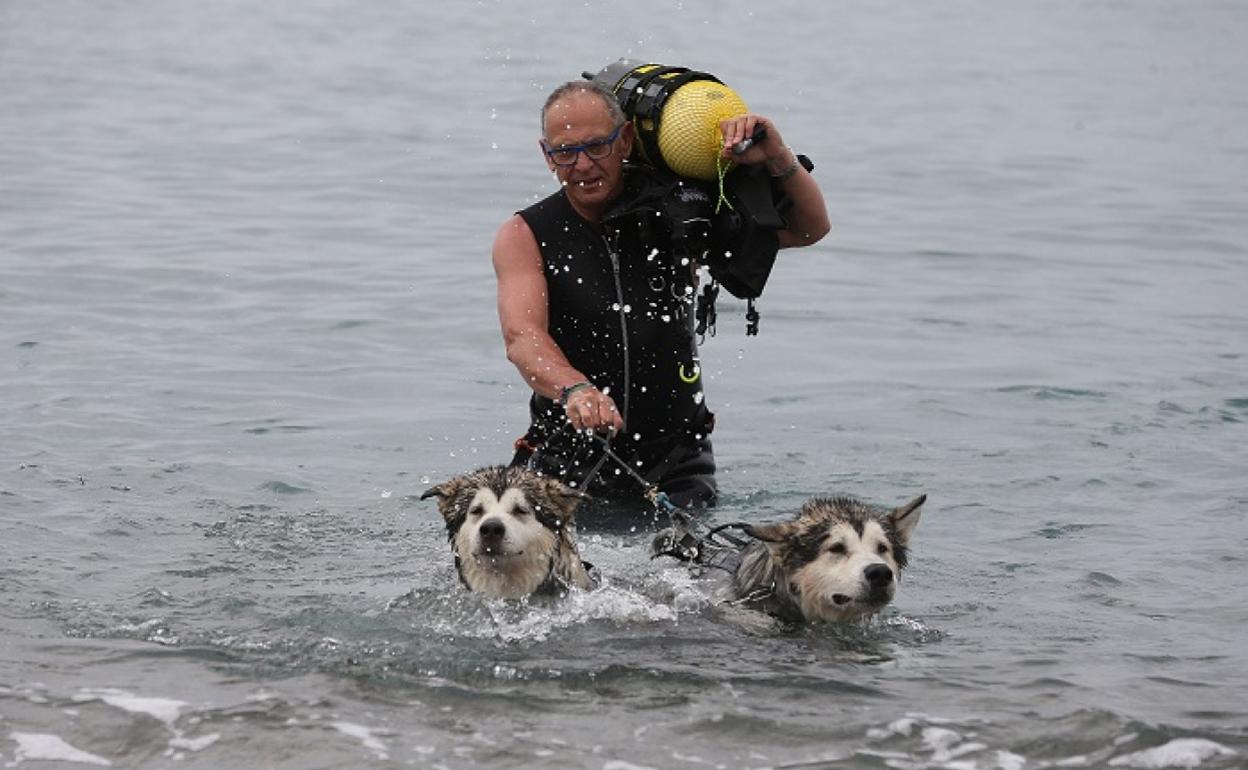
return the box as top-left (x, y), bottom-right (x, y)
top-left (0, 0), bottom-right (1248, 770)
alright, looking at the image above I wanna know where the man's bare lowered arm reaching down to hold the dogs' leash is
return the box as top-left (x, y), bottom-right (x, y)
top-left (494, 215), bottom-right (624, 431)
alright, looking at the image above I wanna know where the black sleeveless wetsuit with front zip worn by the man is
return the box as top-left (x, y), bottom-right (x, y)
top-left (513, 172), bottom-right (715, 505)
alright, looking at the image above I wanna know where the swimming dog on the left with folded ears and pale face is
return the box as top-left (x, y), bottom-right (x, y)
top-left (421, 465), bottom-right (593, 599)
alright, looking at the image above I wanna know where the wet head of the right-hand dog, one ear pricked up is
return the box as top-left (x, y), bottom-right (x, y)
top-left (745, 495), bottom-right (927, 620)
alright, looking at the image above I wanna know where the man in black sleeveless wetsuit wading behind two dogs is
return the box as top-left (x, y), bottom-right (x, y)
top-left (493, 81), bottom-right (830, 507)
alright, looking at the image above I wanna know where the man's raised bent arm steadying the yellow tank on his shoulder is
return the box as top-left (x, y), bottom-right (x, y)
top-left (720, 115), bottom-right (832, 248)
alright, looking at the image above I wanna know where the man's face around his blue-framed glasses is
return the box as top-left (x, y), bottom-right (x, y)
top-left (542, 91), bottom-right (633, 220)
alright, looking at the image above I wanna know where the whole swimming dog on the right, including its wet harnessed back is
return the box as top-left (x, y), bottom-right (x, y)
top-left (653, 495), bottom-right (927, 623)
